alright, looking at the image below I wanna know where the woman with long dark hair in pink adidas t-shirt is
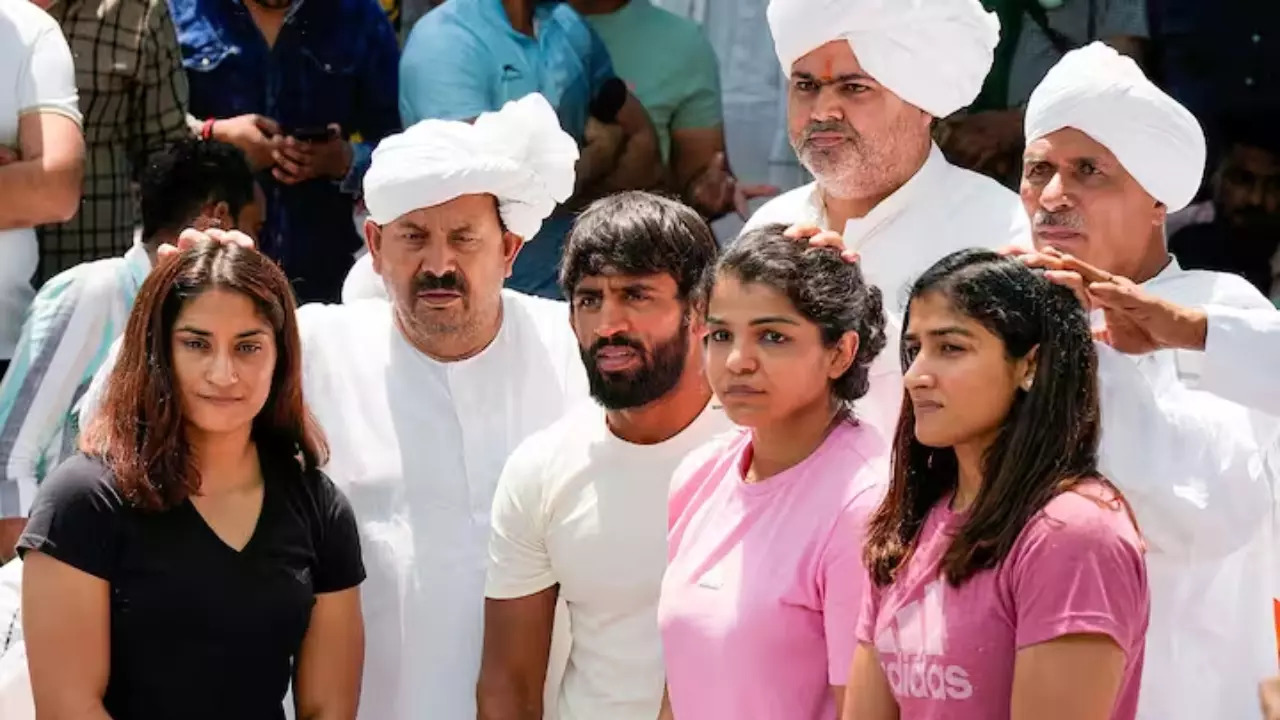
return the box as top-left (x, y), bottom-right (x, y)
top-left (845, 250), bottom-right (1157, 720)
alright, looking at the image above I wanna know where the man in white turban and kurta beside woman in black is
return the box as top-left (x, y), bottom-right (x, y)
top-left (82, 95), bottom-right (589, 720)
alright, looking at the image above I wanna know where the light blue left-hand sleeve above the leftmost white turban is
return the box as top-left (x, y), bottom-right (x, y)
top-left (399, 20), bottom-right (498, 127)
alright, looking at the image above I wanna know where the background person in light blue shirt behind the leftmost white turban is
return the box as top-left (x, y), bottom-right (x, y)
top-left (399, 0), bottom-right (664, 299)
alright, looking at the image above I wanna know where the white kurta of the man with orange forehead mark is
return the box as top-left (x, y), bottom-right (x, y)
top-left (742, 145), bottom-right (1030, 437)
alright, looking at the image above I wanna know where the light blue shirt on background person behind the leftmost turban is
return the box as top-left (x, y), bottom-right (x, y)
top-left (399, 0), bottom-right (614, 297)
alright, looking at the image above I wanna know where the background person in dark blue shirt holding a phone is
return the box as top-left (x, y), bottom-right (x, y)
top-left (173, 0), bottom-right (399, 302)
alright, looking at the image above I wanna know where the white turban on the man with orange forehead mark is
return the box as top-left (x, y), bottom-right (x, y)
top-left (768, 0), bottom-right (1000, 118)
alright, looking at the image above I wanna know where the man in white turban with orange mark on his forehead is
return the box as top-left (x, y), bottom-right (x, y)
top-left (744, 0), bottom-right (1030, 434)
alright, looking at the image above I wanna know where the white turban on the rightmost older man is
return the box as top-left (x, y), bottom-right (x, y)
top-left (1025, 42), bottom-right (1204, 213)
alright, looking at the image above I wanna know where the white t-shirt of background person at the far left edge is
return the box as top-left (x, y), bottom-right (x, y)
top-left (0, 0), bottom-right (81, 360)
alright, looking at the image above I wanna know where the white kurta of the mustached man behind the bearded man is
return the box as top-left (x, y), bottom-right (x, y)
top-left (298, 291), bottom-right (588, 720)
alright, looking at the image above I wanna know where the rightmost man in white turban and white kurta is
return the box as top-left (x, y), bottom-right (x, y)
top-left (1021, 44), bottom-right (1277, 720)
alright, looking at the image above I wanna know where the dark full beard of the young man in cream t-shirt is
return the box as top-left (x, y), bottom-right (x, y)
top-left (580, 318), bottom-right (689, 410)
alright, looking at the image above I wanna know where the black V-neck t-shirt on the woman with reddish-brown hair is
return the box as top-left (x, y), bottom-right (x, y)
top-left (18, 448), bottom-right (365, 720)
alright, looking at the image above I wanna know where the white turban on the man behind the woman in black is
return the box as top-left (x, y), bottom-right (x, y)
top-left (365, 94), bottom-right (579, 240)
